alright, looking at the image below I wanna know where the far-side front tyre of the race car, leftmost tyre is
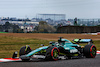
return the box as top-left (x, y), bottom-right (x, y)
top-left (19, 45), bottom-right (32, 61)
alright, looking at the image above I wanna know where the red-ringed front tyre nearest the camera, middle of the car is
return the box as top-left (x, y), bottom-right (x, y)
top-left (45, 46), bottom-right (59, 61)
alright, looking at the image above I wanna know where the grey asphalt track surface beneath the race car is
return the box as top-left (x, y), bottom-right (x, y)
top-left (0, 55), bottom-right (100, 67)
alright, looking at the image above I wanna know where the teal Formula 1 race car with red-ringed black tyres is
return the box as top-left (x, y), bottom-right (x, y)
top-left (19, 37), bottom-right (97, 61)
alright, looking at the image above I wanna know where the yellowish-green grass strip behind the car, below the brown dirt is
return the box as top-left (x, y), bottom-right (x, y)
top-left (0, 36), bottom-right (100, 58)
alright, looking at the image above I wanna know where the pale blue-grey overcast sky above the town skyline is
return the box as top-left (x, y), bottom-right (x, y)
top-left (0, 0), bottom-right (100, 19)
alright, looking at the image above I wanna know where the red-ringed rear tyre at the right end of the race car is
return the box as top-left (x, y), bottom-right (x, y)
top-left (83, 45), bottom-right (97, 58)
